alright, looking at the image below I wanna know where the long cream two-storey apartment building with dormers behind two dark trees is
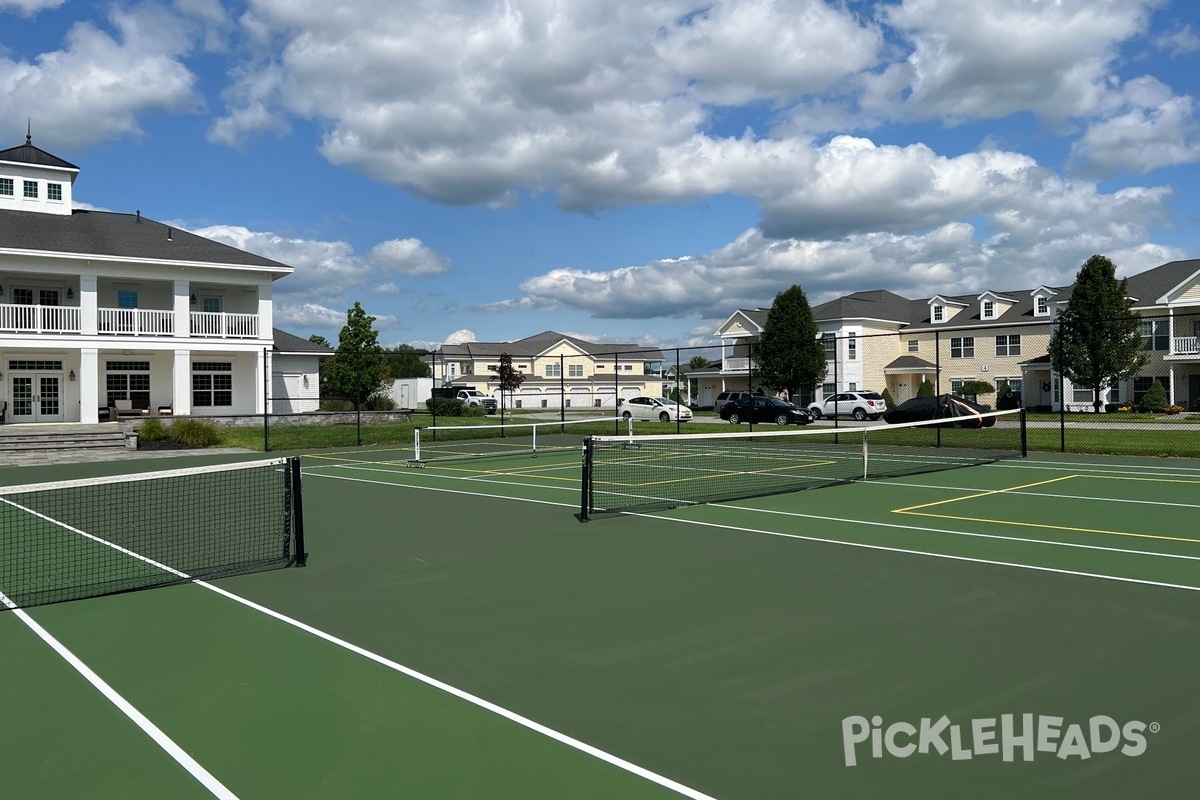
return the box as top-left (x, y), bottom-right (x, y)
top-left (700, 259), bottom-right (1200, 411)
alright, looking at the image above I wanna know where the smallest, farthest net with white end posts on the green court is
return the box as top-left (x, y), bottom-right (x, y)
top-left (407, 416), bottom-right (632, 467)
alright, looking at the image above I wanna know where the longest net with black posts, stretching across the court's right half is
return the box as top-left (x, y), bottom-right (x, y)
top-left (580, 409), bottom-right (1026, 521)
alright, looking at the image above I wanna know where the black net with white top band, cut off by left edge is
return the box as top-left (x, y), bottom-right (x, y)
top-left (0, 458), bottom-right (306, 608)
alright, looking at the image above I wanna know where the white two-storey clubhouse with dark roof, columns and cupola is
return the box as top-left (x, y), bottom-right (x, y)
top-left (0, 136), bottom-right (318, 423)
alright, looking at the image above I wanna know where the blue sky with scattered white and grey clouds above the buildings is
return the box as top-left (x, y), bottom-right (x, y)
top-left (0, 0), bottom-right (1200, 347)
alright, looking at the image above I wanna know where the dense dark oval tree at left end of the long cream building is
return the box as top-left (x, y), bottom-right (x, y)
top-left (755, 285), bottom-right (826, 396)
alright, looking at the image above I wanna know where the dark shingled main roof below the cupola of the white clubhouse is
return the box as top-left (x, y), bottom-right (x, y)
top-left (0, 209), bottom-right (292, 270)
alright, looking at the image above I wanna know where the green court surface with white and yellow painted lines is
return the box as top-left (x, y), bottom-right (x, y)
top-left (0, 438), bottom-right (1200, 800)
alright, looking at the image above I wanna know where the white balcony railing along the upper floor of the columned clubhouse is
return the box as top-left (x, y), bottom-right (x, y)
top-left (0, 303), bottom-right (259, 338)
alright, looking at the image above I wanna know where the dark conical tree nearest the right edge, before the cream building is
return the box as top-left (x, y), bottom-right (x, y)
top-left (1050, 255), bottom-right (1146, 414)
